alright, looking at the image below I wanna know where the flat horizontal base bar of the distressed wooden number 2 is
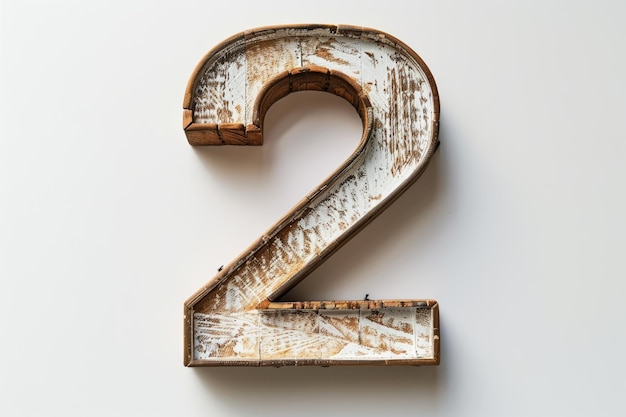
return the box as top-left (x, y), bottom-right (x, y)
top-left (194, 300), bottom-right (438, 366)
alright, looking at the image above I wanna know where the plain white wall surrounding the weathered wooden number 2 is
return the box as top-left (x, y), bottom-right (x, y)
top-left (0, 0), bottom-right (626, 416)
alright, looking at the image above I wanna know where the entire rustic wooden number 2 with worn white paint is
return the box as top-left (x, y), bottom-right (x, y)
top-left (183, 25), bottom-right (439, 366)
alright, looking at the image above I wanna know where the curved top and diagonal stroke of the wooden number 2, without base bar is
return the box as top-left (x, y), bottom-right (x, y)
top-left (183, 25), bottom-right (439, 312)
